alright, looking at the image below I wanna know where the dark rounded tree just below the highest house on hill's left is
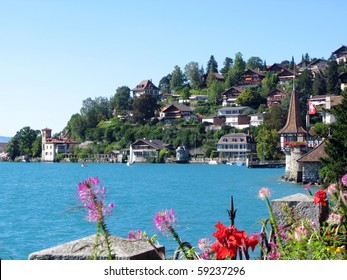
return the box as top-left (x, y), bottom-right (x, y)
top-left (133, 93), bottom-right (159, 124)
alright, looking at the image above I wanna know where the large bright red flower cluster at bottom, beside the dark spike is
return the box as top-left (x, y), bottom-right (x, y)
top-left (211, 222), bottom-right (259, 260)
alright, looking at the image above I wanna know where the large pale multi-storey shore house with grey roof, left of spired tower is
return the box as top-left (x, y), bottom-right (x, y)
top-left (217, 133), bottom-right (256, 160)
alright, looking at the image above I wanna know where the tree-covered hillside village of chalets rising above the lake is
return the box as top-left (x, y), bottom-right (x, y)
top-left (0, 46), bottom-right (347, 184)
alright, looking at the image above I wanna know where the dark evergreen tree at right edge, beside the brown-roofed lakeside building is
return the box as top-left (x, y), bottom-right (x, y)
top-left (320, 90), bottom-right (347, 184)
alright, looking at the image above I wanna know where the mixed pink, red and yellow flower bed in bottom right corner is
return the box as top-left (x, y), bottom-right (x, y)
top-left (259, 174), bottom-right (347, 260)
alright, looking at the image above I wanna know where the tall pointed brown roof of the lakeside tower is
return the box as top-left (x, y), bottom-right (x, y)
top-left (278, 89), bottom-right (306, 134)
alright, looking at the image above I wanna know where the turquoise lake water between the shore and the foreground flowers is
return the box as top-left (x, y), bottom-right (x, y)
top-left (0, 162), bottom-right (305, 260)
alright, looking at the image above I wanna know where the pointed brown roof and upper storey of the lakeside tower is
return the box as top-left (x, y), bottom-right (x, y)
top-left (278, 89), bottom-right (307, 149)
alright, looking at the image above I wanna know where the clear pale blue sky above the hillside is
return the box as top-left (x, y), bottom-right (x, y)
top-left (0, 0), bottom-right (347, 136)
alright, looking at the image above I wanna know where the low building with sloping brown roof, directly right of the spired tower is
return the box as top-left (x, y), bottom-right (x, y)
top-left (297, 141), bottom-right (327, 184)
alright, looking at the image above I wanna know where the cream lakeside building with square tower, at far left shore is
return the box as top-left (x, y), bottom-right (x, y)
top-left (41, 128), bottom-right (77, 162)
